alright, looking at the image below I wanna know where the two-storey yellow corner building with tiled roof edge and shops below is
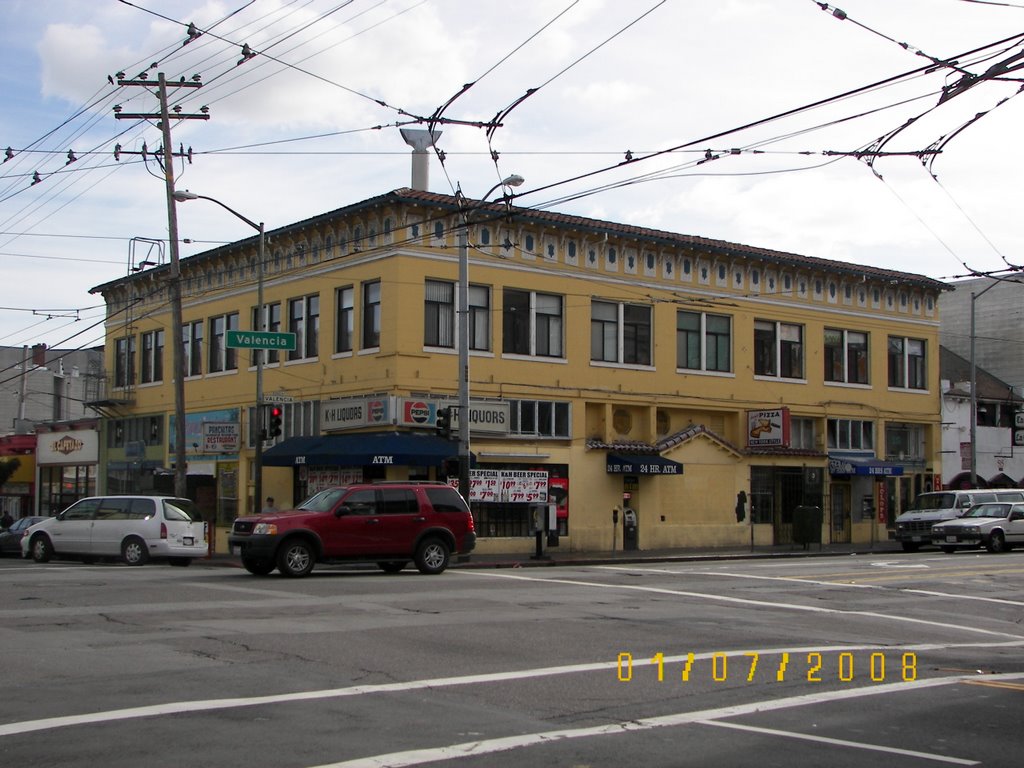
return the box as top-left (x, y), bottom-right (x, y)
top-left (93, 188), bottom-right (944, 552)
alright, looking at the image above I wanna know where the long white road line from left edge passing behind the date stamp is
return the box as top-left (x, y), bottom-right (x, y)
top-left (0, 640), bottom-right (1011, 737)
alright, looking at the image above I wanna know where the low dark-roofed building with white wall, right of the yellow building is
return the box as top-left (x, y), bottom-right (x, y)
top-left (939, 348), bottom-right (1024, 488)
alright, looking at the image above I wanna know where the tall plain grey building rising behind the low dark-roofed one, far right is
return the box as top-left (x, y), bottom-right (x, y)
top-left (939, 275), bottom-right (1024, 394)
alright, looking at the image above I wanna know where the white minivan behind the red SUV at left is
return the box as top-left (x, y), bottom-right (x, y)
top-left (22, 496), bottom-right (207, 565)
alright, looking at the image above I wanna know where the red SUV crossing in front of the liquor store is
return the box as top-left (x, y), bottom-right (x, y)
top-left (227, 482), bottom-right (476, 577)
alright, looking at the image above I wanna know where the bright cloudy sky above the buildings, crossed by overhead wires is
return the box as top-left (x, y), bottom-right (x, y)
top-left (0, 0), bottom-right (1024, 348)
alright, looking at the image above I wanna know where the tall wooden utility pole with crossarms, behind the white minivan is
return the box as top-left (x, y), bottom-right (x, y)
top-left (114, 72), bottom-right (210, 498)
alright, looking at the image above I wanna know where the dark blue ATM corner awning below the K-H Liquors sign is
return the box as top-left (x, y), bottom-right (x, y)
top-left (263, 432), bottom-right (459, 467)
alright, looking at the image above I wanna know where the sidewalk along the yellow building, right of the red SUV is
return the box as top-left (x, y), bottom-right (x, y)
top-left (449, 541), bottom-right (903, 568)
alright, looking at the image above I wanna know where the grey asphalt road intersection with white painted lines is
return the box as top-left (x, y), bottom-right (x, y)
top-left (0, 552), bottom-right (1024, 768)
